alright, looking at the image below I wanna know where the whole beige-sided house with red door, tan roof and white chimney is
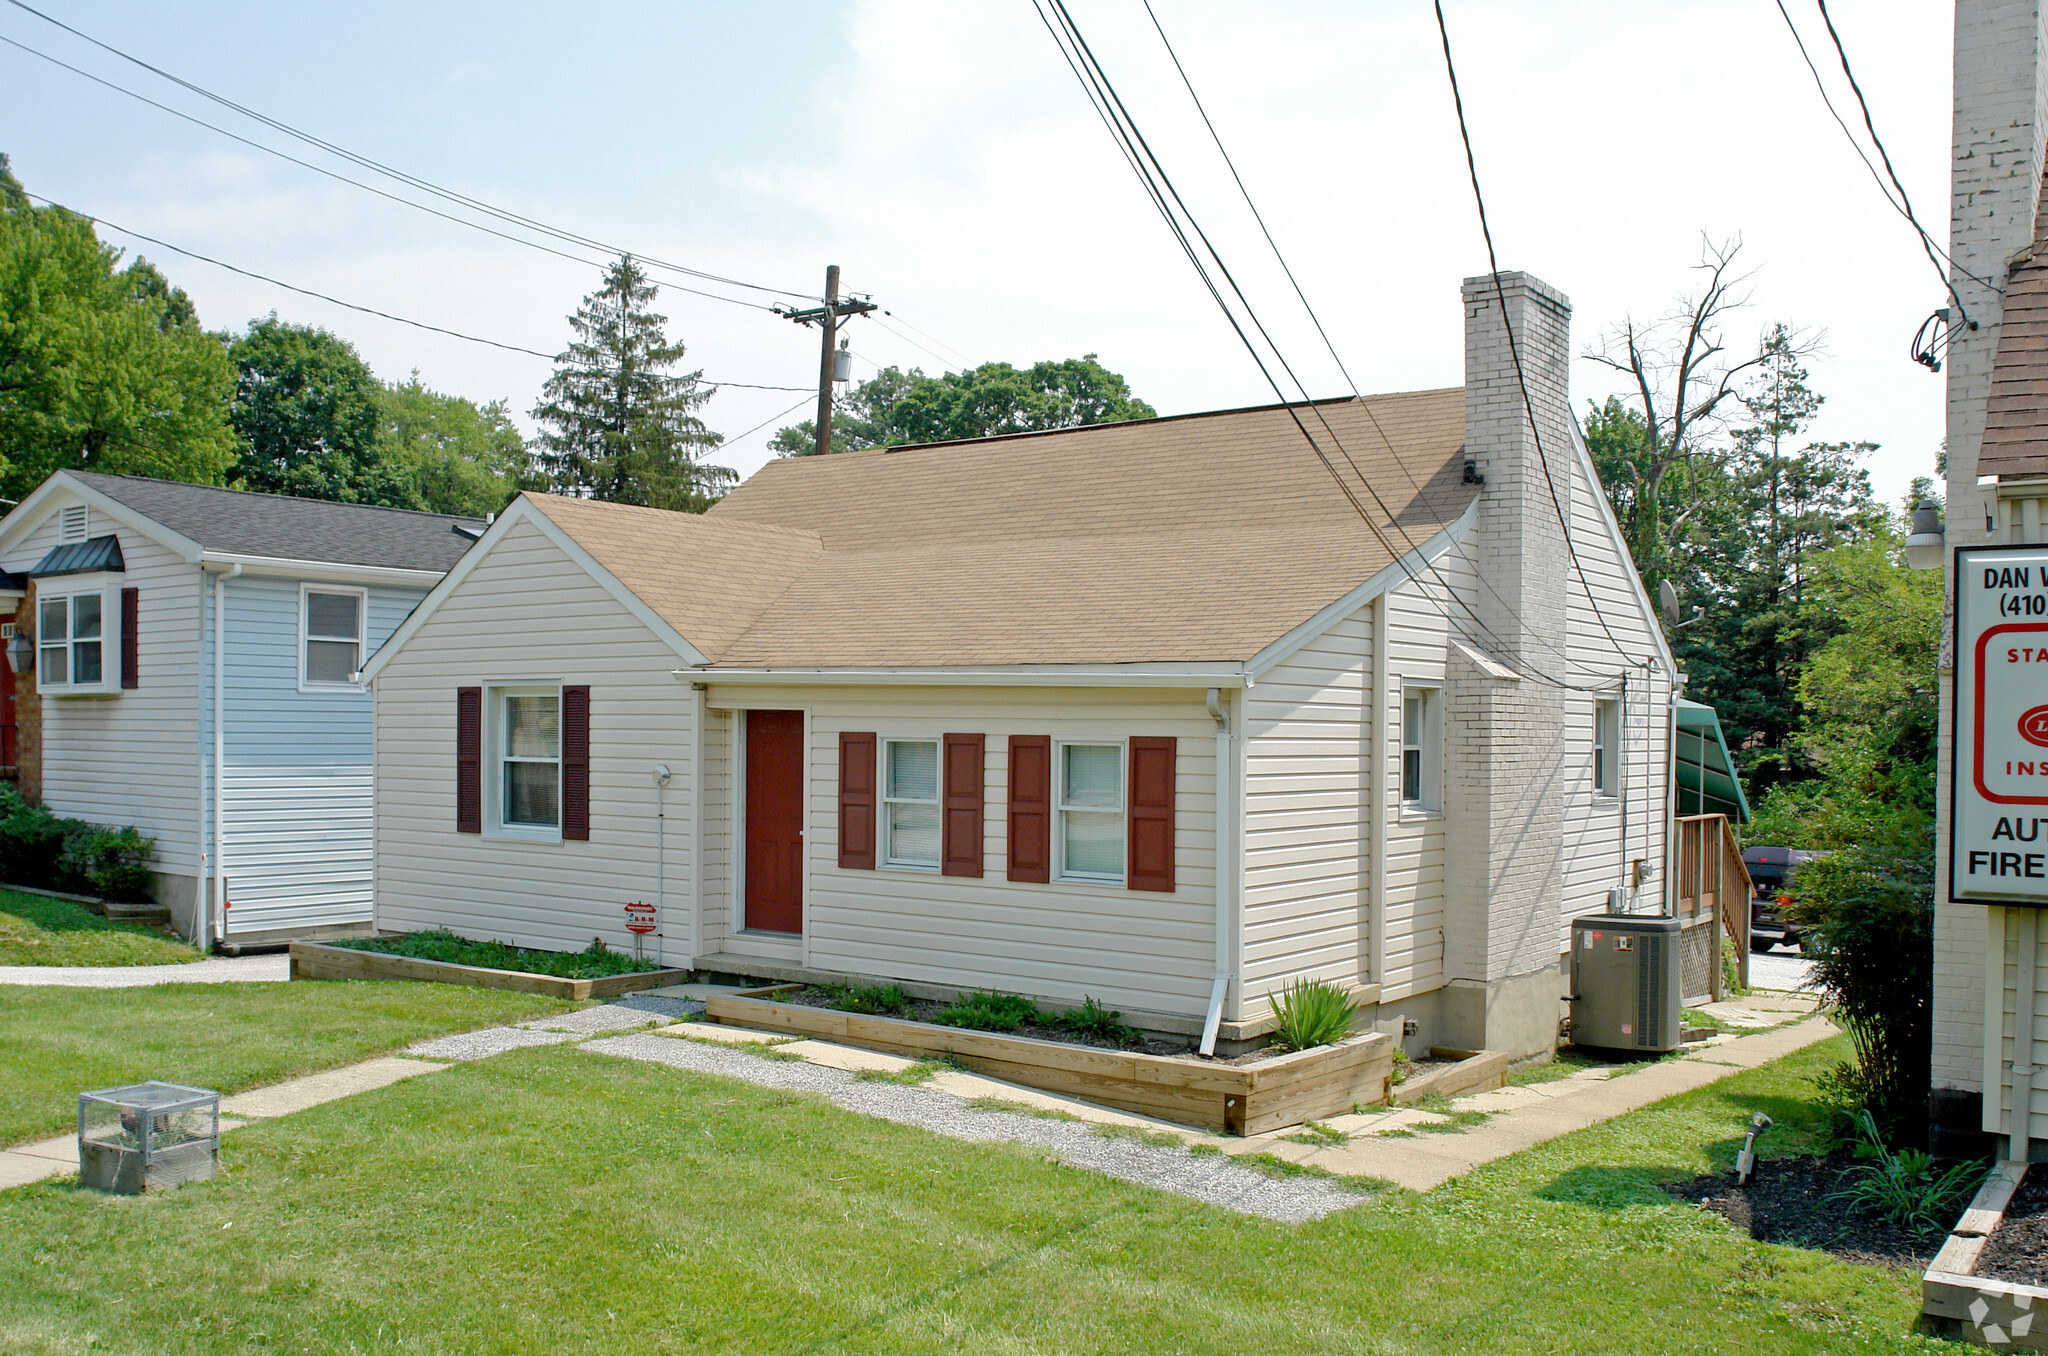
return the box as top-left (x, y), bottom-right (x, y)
top-left (367, 274), bottom-right (1675, 1057)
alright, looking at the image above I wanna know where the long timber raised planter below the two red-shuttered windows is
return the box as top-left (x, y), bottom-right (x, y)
top-left (705, 985), bottom-right (1395, 1135)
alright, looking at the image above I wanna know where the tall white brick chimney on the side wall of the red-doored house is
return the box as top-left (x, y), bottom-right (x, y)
top-left (1444, 272), bottom-right (1573, 1059)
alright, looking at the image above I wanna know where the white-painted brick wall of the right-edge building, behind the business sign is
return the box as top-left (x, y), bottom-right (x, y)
top-left (1933, 0), bottom-right (2048, 1092)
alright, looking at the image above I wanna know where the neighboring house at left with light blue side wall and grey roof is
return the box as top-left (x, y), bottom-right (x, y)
top-left (0, 471), bottom-right (485, 942)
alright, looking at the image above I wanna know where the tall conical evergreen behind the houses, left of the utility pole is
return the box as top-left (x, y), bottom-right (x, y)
top-left (532, 254), bottom-right (737, 514)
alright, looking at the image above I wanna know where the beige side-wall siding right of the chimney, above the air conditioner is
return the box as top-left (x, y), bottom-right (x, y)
top-left (1559, 453), bottom-right (1671, 934)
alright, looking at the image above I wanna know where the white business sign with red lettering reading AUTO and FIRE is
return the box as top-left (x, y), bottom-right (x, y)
top-left (1948, 547), bottom-right (2048, 903)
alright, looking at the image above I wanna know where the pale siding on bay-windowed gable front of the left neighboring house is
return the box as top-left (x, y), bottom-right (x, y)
top-left (0, 503), bottom-right (199, 875)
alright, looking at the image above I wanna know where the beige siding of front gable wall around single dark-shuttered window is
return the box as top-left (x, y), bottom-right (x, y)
top-left (375, 522), bottom-right (696, 961)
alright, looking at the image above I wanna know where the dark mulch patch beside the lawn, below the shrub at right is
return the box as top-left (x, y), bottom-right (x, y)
top-left (1665, 1157), bottom-right (1948, 1270)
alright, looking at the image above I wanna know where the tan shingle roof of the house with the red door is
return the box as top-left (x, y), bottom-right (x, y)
top-left (520, 389), bottom-right (1473, 668)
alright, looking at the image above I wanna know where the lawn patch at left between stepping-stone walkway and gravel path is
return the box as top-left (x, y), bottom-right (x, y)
top-left (0, 981), bottom-right (571, 1147)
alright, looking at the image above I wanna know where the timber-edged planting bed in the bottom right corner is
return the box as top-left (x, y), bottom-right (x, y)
top-left (1921, 1159), bottom-right (2048, 1352)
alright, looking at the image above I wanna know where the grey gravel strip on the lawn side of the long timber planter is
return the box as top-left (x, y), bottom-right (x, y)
top-left (584, 1034), bottom-right (1360, 1225)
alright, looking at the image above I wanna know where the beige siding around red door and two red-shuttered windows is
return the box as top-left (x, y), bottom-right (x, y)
top-left (707, 684), bottom-right (1217, 1018)
